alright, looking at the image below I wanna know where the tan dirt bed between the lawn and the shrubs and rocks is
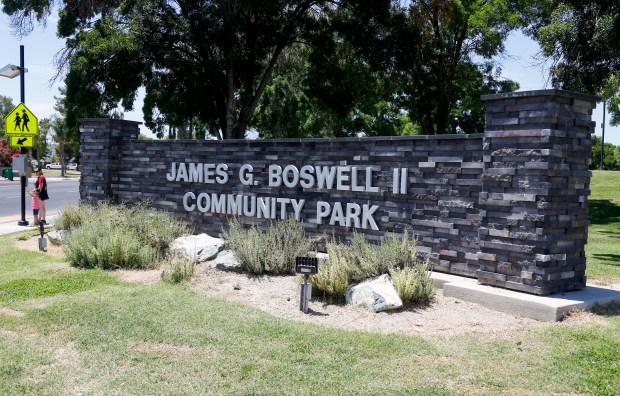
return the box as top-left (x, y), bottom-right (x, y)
top-left (12, 237), bottom-right (602, 339)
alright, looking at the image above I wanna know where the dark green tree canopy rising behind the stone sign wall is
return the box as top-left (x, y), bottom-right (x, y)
top-left (2, 0), bottom-right (542, 139)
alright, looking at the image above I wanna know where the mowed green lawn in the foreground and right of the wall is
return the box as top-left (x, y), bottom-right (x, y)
top-left (0, 173), bottom-right (620, 395)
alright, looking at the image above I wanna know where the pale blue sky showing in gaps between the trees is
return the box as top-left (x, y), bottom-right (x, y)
top-left (0, 12), bottom-right (620, 145)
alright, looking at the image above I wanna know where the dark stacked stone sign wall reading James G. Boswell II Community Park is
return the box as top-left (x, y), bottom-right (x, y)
top-left (80, 90), bottom-right (597, 294)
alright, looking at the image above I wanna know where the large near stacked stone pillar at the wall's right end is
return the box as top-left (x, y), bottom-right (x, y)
top-left (477, 90), bottom-right (599, 294)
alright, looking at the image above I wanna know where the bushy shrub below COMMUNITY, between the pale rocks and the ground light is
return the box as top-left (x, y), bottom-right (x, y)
top-left (223, 218), bottom-right (314, 274)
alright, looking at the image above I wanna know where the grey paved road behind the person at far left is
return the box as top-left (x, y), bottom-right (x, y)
top-left (0, 177), bottom-right (80, 223)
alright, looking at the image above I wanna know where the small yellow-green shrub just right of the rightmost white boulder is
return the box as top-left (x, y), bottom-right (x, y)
top-left (390, 263), bottom-right (436, 304)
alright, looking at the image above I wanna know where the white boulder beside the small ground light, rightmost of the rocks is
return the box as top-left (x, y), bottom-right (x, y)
top-left (346, 274), bottom-right (403, 312)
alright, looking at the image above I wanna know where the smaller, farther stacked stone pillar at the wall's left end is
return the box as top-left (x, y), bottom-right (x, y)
top-left (79, 118), bottom-right (141, 202)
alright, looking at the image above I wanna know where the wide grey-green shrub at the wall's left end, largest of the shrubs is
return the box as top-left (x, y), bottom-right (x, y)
top-left (62, 203), bottom-right (191, 269)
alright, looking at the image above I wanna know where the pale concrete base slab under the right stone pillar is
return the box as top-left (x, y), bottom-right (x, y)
top-left (431, 272), bottom-right (620, 322)
